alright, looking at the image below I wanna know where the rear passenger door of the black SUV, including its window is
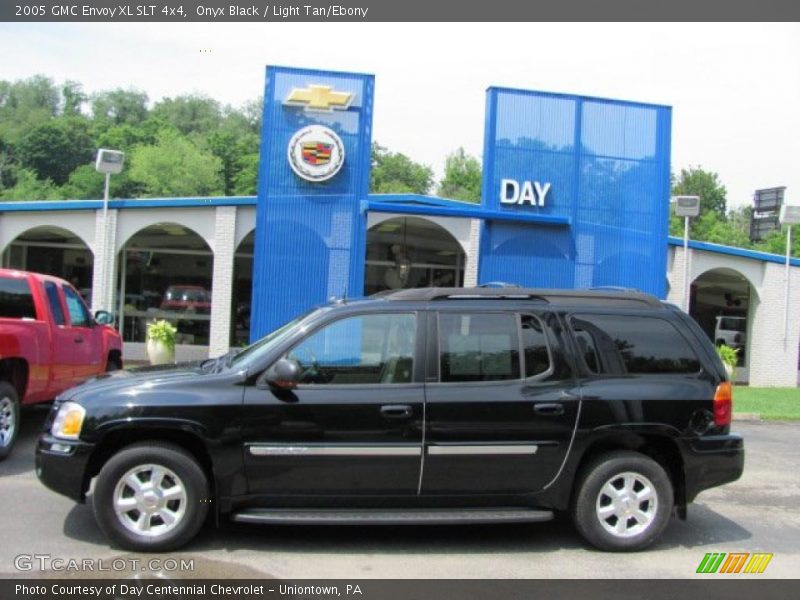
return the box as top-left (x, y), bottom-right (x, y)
top-left (421, 310), bottom-right (580, 495)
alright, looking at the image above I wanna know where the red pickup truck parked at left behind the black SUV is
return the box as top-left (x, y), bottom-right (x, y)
top-left (0, 269), bottom-right (122, 460)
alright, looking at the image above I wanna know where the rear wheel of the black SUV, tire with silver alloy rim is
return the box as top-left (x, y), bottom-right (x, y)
top-left (572, 451), bottom-right (674, 551)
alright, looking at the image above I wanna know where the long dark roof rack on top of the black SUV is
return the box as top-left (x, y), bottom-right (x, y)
top-left (373, 287), bottom-right (664, 308)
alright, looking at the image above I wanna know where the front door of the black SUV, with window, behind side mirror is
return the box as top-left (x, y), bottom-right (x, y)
top-left (244, 311), bottom-right (424, 497)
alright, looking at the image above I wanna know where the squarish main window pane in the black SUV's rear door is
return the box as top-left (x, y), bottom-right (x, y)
top-left (439, 313), bottom-right (520, 382)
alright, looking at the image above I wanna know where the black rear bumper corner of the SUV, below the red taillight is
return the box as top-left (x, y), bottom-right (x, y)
top-left (683, 434), bottom-right (744, 502)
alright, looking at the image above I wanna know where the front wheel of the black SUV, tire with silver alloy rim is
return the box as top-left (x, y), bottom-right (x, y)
top-left (92, 442), bottom-right (209, 552)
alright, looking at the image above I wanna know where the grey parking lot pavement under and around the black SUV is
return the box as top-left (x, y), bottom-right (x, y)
top-left (0, 408), bottom-right (800, 579)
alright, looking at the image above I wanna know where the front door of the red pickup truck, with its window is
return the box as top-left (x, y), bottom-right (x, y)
top-left (61, 285), bottom-right (105, 382)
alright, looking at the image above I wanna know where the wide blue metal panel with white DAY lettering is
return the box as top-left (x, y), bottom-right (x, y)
top-left (479, 88), bottom-right (670, 298)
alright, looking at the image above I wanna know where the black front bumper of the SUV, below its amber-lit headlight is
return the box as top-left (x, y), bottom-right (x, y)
top-left (36, 433), bottom-right (94, 502)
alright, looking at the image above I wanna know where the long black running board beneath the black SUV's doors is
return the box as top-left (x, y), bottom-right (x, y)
top-left (231, 508), bottom-right (553, 525)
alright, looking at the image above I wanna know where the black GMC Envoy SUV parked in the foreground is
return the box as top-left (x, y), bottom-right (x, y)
top-left (36, 288), bottom-right (744, 551)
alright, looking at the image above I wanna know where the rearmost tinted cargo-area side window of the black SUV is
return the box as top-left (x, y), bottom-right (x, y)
top-left (571, 315), bottom-right (700, 375)
